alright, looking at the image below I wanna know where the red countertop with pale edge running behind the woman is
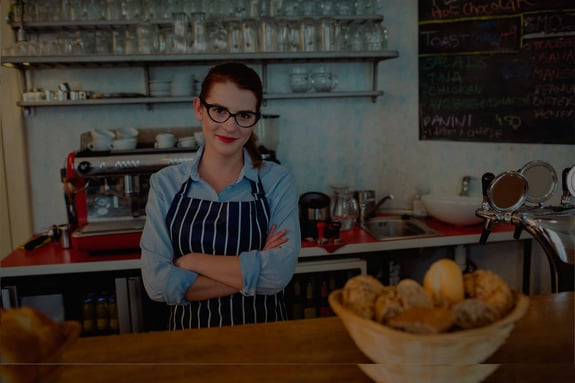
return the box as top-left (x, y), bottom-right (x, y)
top-left (0, 218), bottom-right (514, 277)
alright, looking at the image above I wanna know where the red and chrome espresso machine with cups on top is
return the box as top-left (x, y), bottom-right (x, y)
top-left (62, 148), bottom-right (196, 252)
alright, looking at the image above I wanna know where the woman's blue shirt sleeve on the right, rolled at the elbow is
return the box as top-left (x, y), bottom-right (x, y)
top-left (240, 165), bottom-right (301, 295)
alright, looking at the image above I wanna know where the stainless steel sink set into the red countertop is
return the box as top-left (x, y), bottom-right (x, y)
top-left (360, 217), bottom-right (441, 241)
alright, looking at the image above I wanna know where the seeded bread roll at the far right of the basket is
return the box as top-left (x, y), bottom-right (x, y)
top-left (464, 270), bottom-right (513, 318)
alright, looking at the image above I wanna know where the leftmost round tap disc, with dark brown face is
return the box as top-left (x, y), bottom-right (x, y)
top-left (487, 171), bottom-right (528, 212)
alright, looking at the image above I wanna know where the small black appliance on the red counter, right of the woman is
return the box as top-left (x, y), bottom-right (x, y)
top-left (299, 192), bottom-right (330, 240)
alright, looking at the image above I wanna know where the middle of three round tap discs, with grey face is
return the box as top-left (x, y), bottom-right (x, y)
top-left (519, 161), bottom-right (557, 204)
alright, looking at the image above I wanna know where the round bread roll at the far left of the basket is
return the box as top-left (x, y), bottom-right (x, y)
top-left (342, 274), bottom-right (384, 319)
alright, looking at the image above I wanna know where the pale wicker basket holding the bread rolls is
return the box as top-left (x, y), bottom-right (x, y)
top-left (329, 289), bottom-right (529, 382)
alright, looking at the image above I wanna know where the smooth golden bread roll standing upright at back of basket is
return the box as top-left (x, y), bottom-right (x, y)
top-left (423, 258), bottom-right (465, 308)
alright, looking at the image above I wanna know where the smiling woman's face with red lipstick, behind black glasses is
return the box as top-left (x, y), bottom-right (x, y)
top-left (194, 82), bottom-right (257, 156)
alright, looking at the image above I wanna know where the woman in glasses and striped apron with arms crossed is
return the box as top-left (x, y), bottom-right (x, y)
top-left (140, 63), bottom-right (301, 329)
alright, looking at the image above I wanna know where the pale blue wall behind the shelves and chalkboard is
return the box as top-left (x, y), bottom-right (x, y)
top-left (22, 0), bottom-right (575, 231)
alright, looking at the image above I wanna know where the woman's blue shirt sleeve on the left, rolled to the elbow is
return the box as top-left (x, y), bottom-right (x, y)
top-left (140, 173), bottom-right (197, 304)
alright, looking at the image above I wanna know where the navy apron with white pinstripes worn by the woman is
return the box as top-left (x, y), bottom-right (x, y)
top-left (166, 178), bottom-right (287, 330)
